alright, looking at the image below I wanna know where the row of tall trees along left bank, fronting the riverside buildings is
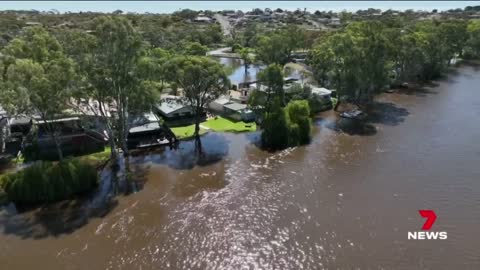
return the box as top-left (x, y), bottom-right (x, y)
top-left (0, 16), bottom-right (228, 166)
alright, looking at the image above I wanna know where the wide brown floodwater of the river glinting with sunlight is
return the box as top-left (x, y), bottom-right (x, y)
top-left (0, 66), bottom-right (480, 270)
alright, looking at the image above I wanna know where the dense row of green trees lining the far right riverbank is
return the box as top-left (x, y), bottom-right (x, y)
top-left (309, 20), bottom-right (480, 105)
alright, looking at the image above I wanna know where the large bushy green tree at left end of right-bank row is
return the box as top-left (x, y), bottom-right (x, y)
top-left (310, 21), bottom-right (392, 105)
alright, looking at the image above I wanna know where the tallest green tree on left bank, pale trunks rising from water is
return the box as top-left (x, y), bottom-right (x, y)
top-left (76, 16), bottom-right (158, 165)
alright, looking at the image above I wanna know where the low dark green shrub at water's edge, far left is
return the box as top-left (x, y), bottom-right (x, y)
top-left (0, 160), bottom-right (98, 204)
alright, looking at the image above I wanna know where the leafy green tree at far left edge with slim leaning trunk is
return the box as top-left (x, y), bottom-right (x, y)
top-left (1, 27), bottom-right (75, 160)
